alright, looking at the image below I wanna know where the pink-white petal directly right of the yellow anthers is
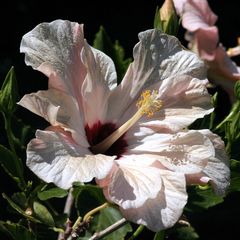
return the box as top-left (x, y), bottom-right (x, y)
top-left (124, 75), bottom-right (214, 134)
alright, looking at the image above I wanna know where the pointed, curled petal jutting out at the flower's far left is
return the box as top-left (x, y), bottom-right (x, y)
top-left (18, 89), bottom-right (89, 147)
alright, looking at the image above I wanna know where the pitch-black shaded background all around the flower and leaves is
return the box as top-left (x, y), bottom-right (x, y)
top-left (0, 0), bottom-right (240, 240)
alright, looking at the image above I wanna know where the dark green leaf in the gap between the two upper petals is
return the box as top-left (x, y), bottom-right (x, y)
top-left (93, 26), bottom-right (131, 84)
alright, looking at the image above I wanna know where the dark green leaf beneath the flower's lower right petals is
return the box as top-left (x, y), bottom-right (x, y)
top-left (186, 186), bottom-right (223, 211)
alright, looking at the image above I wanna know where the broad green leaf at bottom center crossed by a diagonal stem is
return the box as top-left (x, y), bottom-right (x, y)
top-left (91, 207), bottom-right (132, 240)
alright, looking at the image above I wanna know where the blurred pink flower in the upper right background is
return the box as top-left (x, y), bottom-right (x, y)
top-left (174, 0), bottom-right (240, 100)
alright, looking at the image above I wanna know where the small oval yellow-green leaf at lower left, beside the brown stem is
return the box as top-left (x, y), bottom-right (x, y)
top-left (33, 202), bottom-right (55, 227)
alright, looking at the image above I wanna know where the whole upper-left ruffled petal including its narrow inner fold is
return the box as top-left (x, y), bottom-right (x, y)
top-left (20, 20), bottom-right (117, 125)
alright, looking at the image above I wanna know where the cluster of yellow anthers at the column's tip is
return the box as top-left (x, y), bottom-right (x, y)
top-left (136, 90), bottom-right (162, 117)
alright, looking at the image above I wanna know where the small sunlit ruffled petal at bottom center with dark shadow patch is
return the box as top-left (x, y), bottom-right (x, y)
top-left (107, 155), bottom-right (162, 209)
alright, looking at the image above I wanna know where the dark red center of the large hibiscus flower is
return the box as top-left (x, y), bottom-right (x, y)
top-left (85, 121), bottom-right (128, 158)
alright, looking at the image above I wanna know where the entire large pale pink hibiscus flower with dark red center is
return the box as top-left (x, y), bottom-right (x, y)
top-left (19, 20), bottom-right (229, 231)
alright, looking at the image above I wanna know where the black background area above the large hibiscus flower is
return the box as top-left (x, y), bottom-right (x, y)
top-left (0, 0), bottom-right (240, 95)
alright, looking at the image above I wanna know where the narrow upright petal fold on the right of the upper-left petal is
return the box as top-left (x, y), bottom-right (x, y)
top-left (81, 42), bottom-right (117, 126)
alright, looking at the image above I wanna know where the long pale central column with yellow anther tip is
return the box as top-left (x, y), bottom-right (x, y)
top-left (91, 90), bottom-right (163, 153)
